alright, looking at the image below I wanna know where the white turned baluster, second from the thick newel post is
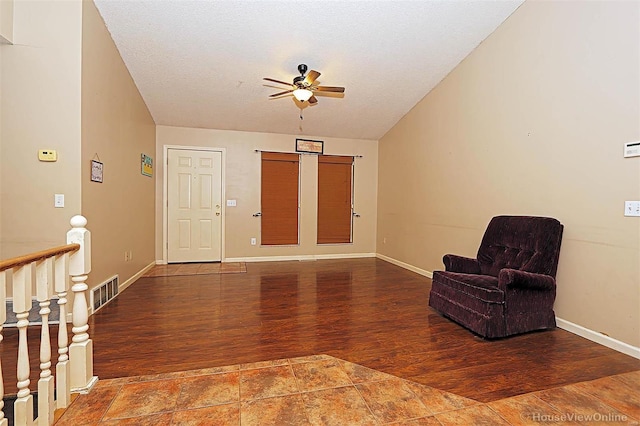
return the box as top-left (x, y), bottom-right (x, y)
top-left (36, 258), bottom-right (55, 426)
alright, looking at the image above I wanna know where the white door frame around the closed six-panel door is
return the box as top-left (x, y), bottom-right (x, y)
top-left (162, 145), bottom-right (227, 264)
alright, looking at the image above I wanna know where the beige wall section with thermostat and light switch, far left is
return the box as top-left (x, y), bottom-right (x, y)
top-left (0, 0), bottom-right (82, 258)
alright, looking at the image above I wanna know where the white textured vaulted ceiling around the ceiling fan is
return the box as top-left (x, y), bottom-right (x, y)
top-left (95, 0), bottom-right (522, 139)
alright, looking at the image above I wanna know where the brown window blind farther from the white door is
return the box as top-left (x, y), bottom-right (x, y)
top-left (317, 155), bottom-right (353, 244)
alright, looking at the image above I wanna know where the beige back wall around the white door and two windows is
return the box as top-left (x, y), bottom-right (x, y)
top-left (156, 126), bottom-right (378, 260)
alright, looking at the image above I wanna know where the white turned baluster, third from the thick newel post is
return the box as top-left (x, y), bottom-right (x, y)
top-left (13, 262), bottom-right (35, 425)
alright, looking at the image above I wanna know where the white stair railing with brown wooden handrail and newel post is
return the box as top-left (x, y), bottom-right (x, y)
top-left (0, 215), bottom-right (98, 426)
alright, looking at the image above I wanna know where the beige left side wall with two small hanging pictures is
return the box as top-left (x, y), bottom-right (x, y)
top-left (81, 1), bottom-right (155, 287)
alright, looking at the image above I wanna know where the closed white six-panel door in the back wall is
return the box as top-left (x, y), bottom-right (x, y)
top-left (167, 149), bottom-right (222, 262)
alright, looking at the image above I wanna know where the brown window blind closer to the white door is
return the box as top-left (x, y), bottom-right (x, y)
top-left (260, 152), bottom-right (300, 246)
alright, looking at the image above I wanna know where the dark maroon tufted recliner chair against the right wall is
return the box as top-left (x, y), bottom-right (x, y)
top-left (429, 216), bottom-right (563, 338)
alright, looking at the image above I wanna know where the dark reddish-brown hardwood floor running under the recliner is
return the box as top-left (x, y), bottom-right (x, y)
top-left (2, 259), bottom-right (640, 402)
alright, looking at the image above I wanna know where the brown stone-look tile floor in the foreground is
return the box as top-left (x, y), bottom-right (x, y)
top-left (56, 355), bottom-right (640, 426)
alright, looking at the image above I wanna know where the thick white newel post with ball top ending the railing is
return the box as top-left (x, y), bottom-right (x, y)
top-left (66, 215), bottom-right (98, 393)
